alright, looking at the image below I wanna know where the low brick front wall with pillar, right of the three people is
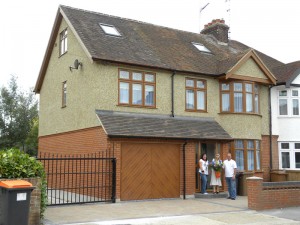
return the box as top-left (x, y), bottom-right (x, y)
top-left (247, 177), bottom-right (300, 210)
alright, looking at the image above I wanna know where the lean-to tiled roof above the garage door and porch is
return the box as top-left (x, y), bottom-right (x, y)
top-left (96, 110), bottom-right (232, 140)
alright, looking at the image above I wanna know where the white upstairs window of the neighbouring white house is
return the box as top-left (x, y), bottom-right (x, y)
top-left (278, 89), bottom-right (300, 117)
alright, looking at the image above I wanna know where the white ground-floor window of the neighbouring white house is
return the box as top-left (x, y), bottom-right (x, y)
top-left (278, 142), bottom-right (300, 170)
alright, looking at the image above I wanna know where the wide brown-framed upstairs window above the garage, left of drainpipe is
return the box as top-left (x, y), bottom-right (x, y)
top-left (119, 69), bottom-right (156, 108)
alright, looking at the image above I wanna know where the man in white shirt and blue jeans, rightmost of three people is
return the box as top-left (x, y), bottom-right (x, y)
top-left (224, 153), bottom-right (237, 200)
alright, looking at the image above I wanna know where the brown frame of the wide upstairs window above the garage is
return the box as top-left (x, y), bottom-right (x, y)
top-left (118, 68), bottom-right (156, 108)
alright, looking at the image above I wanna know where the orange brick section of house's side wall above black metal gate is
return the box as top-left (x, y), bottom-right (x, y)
top-left (39, 127), bottom-right (107, 154)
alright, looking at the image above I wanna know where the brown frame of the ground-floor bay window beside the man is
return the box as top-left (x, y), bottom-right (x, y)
top-left (231, 139), bottom-right (262, 172)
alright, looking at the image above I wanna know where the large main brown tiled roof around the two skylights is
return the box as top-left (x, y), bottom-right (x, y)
top-left (60, 6), bottom-right (282, 75)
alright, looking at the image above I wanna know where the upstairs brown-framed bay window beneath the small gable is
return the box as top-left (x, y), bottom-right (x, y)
top-left (220, 81), bottom-right (259, 114)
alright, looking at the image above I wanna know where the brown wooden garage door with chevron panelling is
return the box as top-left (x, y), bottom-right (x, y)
top-left (121, 143), bottom-right (180, 200)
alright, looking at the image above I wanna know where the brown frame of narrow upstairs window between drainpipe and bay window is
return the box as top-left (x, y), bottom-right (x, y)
top-left (184, 77), bottom-right (207, 112)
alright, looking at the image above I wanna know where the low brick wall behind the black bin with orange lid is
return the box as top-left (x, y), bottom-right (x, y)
top-left (0, 178), bottom-right (41, 225)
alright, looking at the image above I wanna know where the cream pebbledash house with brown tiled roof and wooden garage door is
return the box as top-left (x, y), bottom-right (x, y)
top-left (35, 6), bottom-right (284, 200)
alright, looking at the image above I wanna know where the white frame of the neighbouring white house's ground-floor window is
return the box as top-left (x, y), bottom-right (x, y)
top-left (278, 141), bottom-right (300, 171)
